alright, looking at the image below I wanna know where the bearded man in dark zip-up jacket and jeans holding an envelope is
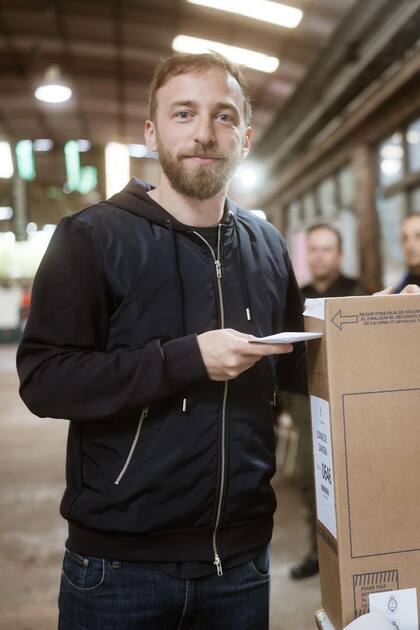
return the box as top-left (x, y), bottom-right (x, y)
top-left (17, 54), bottom-right (306, 630)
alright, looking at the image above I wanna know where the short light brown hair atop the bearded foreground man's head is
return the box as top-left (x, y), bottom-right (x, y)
top-left (149, 52), bottom-right (252, 125)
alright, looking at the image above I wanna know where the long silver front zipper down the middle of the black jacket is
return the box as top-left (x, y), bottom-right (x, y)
top-left (193, 223), bottom-right (229, 576)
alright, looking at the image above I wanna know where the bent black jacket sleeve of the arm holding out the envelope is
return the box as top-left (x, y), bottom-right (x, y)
top-left (17, 217), bottom-right (207, 420)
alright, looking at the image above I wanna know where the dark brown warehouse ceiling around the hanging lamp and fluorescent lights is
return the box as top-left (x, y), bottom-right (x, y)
top-left (0, 0), bottom-right (356, 144)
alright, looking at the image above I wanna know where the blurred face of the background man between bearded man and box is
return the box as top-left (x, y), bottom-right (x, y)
top-left (308, 228), bottom-right (342, 280)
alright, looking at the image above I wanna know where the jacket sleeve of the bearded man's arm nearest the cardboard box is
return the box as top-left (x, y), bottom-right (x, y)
top-left (277, 248), bottom-right (308, 395)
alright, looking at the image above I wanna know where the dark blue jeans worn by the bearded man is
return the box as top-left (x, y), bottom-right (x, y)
top-left (59, 549), bottom-right (270, 630)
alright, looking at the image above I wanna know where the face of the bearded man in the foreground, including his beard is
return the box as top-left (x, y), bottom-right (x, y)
top-left (146, 68), bottom-right (251, 199)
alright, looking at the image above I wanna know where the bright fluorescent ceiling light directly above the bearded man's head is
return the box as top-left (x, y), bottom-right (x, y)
top-left (172, 35), bottom-right (280, 72)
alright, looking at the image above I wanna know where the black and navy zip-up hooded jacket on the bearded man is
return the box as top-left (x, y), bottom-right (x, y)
top-left (17, 180), bottom-right (306, 562)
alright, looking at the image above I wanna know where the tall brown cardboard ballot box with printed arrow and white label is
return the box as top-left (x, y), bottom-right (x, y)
top-left (305, 295), bottom-right (420, 630)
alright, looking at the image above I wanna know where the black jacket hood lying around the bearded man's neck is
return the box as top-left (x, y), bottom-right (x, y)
top-left (106, 177), bottom-right (237, 232)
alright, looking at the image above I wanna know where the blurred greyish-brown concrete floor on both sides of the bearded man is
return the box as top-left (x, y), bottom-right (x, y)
top-left (0, 346), bottom-right (320, 630)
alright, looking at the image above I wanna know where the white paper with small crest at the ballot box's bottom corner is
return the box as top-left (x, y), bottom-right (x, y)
top-left (369, 588), bottom-right (419, 630)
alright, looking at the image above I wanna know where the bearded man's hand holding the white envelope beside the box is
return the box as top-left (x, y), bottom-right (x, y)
top-left (197, 328), bottom-right (293, 381)
